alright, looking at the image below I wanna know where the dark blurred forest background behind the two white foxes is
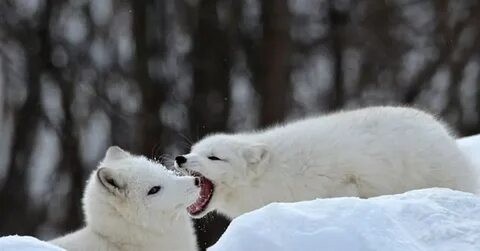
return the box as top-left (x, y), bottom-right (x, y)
top-left (0, 0), bottom-right (480, 248)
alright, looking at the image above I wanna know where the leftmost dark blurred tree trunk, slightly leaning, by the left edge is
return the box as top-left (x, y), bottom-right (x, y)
top-left (0, 10), bottom-right (50, 235)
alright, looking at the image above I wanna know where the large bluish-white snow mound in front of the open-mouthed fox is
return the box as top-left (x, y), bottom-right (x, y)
top-left (209, 188), bottom-right (480, 251)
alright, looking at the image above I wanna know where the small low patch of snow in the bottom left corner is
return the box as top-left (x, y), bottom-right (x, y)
top-left (0, 235), bottom-right (65, 251)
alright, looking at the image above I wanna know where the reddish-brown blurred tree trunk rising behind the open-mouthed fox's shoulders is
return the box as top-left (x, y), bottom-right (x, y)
top-left (254, 0), bottom-right (291, 126)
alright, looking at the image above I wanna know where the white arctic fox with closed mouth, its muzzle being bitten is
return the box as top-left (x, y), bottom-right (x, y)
top-left (51, 146), bottom-right (200, 251)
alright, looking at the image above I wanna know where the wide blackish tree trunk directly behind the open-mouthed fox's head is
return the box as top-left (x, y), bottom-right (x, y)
top-left (189, 0), bottom-right (232, 250)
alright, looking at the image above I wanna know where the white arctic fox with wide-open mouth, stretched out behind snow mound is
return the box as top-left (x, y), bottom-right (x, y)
top-left (175, 107), bottom-right (477, 218)
